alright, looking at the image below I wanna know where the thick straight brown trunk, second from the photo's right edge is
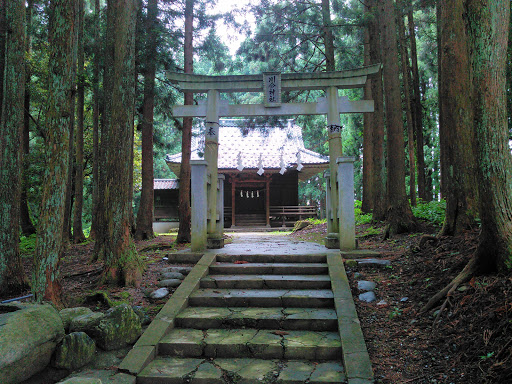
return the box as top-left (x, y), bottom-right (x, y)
top-left (437, 0), bottom-right (476, 236)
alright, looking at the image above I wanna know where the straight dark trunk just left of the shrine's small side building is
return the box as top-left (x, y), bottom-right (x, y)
top-left (135, 0), bottom-right (158, 240)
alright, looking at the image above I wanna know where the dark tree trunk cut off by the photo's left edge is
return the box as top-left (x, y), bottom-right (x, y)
top-left (0, 0), bottom-right (26, 293)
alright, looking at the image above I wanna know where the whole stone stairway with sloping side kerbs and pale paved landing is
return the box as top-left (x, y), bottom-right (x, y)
top-left (120, 233), bottom-right (373, 384)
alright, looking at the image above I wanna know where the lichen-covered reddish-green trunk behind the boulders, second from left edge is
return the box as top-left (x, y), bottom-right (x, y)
top-left (32, 0), bottom-right (76, 306)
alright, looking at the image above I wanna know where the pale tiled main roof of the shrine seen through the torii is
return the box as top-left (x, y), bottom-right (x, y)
top-left (166, 119), bottom-right (329, 178)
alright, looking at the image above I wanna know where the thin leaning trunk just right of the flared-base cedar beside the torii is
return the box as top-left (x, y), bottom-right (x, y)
top-left (407, 6), bottom-right (426, 201)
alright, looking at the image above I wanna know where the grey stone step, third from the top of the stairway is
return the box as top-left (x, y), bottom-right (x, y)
top-left (201, 275), bottom-right (331, 289)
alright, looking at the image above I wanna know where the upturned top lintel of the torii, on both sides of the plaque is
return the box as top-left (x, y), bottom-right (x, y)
top-left (167, 64), bottom-right (381, 93)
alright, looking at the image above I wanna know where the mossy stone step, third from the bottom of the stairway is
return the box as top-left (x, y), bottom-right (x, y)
top-left (175, 307), bottom-right (338, 331)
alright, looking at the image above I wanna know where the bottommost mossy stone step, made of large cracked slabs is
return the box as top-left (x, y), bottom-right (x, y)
top-left (137, 357), bottom-right (347, 384)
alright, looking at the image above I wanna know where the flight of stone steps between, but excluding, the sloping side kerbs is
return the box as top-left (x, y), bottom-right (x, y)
top-left (130, 254), bottom-right (366, 384)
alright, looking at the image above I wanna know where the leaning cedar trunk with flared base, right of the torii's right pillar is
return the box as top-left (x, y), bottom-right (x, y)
top-left (380, 0), bottom-right (414, 235)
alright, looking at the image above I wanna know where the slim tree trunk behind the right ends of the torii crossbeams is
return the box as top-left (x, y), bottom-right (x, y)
top-left (361, 26), bottom-right (373, 213)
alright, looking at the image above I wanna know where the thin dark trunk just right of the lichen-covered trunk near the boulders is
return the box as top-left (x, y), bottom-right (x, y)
top-left (73, 0), bottom-right (85, 243)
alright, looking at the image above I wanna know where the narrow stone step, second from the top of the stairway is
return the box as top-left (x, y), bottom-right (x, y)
top-left (210, 262), bottom-right (328, 275)
